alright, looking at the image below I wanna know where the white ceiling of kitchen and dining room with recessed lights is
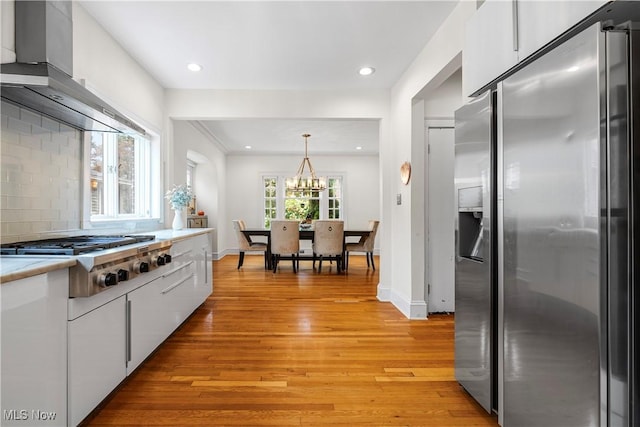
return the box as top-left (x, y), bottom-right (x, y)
top-left (80, 0), bottom-right (458, 154)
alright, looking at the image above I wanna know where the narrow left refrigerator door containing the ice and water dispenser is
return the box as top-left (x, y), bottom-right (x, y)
top-left (454, 88), bottom-right (497, 412)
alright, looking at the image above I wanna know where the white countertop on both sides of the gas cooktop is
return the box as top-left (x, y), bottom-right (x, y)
top-left (0, 228), bottom-right (213, 284)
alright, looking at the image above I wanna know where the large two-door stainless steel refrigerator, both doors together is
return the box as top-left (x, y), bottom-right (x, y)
top-left (455, 9), bottom-right (640, 427)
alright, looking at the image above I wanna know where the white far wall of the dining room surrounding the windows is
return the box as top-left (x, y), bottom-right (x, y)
top-left (222, 155), bottom-right (380, 254)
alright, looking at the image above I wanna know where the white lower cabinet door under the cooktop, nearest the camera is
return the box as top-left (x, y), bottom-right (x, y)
top-left (69, 295), bottom-right (127, 426)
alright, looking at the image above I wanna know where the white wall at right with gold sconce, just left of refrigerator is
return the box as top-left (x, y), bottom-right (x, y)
top-left (378, 1), bottom-right (476, 318)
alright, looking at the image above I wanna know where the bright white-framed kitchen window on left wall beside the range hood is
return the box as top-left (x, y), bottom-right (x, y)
top-left (88, 132), bottom-right (160, 221)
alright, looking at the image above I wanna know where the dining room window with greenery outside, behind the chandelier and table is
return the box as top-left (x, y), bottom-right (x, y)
top-left (263, 176), bottom-right (344, 228)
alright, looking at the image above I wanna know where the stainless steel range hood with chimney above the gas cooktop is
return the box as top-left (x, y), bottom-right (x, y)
top-left (0, 0), bottom-right (145, 134)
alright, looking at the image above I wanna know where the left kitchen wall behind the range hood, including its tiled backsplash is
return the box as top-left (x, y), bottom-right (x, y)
top-left (0, 1), bottom-right (164, 242)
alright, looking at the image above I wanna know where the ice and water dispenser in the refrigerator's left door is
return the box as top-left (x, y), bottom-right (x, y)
top-left (458, 186), bottom-right (484, 261)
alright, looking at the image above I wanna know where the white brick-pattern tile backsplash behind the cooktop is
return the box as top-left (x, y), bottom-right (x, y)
top-left (0, 98), bottom-right (82, 243)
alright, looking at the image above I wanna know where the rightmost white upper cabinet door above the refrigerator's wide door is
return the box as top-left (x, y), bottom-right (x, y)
top-left (517, 0), bottom-right (607, 61)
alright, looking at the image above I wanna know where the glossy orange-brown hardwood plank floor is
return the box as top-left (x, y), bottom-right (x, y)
top-left (87, 256), bottom-right (497, 427)
